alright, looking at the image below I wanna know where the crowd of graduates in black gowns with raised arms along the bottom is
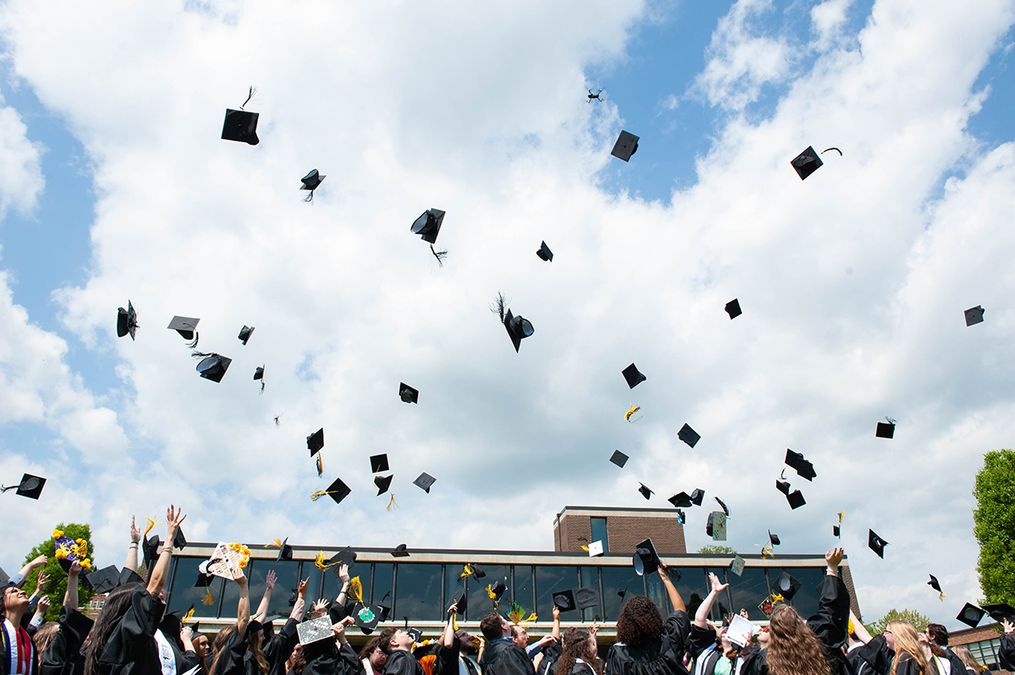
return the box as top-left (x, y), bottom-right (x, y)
top-left (0, 507), bottom-right (1015, 675)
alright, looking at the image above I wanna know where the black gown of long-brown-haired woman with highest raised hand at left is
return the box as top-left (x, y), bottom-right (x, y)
top-left (97, 586), bottom-right (165, 675)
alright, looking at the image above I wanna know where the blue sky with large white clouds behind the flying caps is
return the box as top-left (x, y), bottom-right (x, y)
top-left (0, 0), bottom-right (1015, 627)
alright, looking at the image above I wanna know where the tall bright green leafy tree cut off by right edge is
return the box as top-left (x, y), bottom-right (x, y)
top-left (972, 450), bottom-right (1015, 604)
